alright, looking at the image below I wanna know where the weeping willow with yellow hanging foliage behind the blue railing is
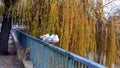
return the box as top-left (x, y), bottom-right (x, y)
top-left (8, 0), bottom-right (116, 68)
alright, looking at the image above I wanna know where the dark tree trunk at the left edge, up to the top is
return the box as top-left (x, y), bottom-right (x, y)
top-left (0, 0), bottom-right (16, 55)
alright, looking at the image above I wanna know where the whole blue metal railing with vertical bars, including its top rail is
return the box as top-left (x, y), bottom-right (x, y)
top-left (11, 29), bottom-right (105, 68)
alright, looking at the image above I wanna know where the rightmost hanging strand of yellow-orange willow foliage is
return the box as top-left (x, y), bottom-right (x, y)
top-left (106, 20), bottom-right (116, 68)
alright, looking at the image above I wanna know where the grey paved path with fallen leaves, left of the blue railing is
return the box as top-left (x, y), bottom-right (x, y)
top-left (0, 35), bottom-right (23, 68)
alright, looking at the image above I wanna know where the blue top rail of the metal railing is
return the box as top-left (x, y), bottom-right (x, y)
top-left (12, 28), bottom-right (106, 68)
